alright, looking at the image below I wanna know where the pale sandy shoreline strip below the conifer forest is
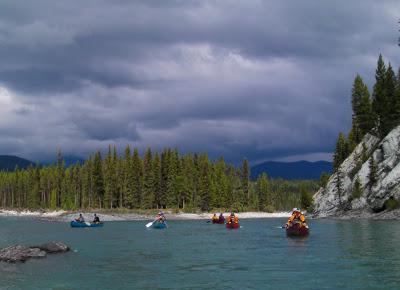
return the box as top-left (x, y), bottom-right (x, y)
top-left (0, 210), bottom-right (290, 221)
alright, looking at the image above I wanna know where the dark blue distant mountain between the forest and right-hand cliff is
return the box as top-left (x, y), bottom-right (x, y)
top-left (251, 161), bottom-right (332, 179)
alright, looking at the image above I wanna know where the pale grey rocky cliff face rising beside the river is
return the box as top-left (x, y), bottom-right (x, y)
top-left (314, 126), bottom-right (400, 217)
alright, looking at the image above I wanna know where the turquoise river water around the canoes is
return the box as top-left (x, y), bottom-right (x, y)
top-left (0, 218), bottom-right (400, 290)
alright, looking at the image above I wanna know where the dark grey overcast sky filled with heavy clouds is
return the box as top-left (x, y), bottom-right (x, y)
top-left (0, 0), bottom-right (400, 163)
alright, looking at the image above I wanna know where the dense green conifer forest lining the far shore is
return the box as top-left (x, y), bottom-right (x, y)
top-left (0, 146), bottom-right (318, 211)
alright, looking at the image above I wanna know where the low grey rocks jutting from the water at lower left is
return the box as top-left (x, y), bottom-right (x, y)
top-left (0, 242), bottom-right (70, 263)
